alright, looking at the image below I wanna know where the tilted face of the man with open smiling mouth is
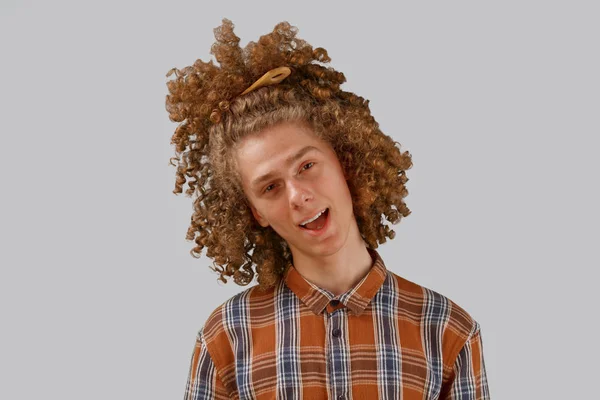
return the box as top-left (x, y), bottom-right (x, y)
top-left (235, 122), bottom-right (357, 257)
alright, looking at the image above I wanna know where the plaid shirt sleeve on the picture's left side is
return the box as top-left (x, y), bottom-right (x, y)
top-left (184, 328), bottom-right (229, 400)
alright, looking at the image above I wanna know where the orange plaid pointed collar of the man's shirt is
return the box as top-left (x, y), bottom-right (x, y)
top-left (284, 247), bottom-right (387, 315)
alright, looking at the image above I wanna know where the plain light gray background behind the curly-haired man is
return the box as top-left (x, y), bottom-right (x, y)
top-left (0, 0), bottom-right (600, 399)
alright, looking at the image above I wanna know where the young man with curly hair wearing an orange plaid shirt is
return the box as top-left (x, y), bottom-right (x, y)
top-left (167, 20), bottom-right (489, 400)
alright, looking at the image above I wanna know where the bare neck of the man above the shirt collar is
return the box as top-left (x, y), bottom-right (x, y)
top-left (294, 231), bottom-right (373, 296)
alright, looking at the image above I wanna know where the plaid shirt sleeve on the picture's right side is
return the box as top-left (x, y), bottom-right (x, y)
top-left (443, 326), bottom-right (490, 400)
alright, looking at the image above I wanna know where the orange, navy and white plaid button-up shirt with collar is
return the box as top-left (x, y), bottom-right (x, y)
top-left (184, 248), bottom-right (490, 400)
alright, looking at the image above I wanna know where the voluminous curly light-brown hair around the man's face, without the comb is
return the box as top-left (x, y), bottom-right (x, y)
top-left (166, 19), bottom-right (412, 289)
